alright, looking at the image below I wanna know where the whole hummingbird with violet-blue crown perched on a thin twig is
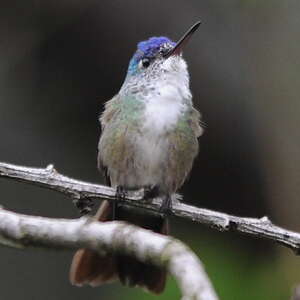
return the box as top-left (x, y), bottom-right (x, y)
top-left (70, 22), bottom-right (203, 294)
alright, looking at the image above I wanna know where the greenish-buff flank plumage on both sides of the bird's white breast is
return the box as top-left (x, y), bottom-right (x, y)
top-left (98, 96), bottom-right (202, 193)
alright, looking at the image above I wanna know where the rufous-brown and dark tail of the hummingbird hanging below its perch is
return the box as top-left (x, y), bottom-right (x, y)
top-left (70, 201), bottom-right (168, 294)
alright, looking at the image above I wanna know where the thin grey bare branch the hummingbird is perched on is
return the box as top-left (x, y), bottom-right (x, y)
top-left (0, 163), bottom-right (300, 254)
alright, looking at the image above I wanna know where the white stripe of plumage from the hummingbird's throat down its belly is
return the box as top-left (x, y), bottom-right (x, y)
top-left (130, 57), bottom-right (191, 185)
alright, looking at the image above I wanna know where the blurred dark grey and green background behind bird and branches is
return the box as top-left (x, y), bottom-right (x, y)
top-left (0, 0), bottom-right (300, 300)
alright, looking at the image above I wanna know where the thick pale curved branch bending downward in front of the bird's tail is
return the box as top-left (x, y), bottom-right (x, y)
top-left (0, 209), bottom-right (218, 300)
